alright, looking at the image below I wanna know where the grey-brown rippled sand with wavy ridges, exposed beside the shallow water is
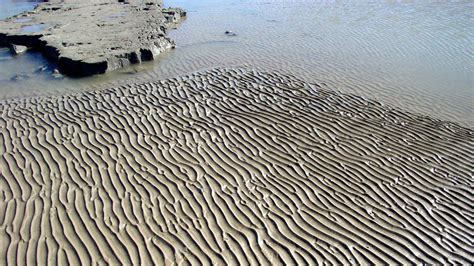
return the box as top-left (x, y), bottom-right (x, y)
top-left (0, 69), bottom-right (474, 265)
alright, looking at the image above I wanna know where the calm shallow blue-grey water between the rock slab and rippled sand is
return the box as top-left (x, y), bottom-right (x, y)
top-left (0, 0), bottom-right (474, 126)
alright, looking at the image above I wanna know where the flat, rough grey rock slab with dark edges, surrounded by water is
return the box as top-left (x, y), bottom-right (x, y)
top-left (0, 0), bottom-right (186, 76)
